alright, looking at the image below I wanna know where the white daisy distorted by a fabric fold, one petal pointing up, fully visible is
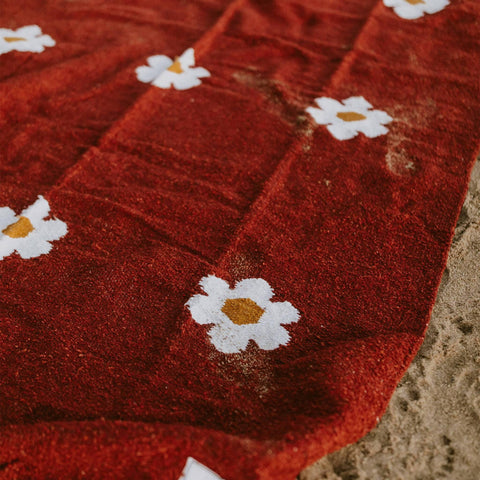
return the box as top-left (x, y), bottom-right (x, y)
top-left (135, 48), bottom-right (210, 90)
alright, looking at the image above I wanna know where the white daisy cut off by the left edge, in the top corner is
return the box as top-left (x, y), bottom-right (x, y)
top-left (0, 25), bottom-right (55, 55)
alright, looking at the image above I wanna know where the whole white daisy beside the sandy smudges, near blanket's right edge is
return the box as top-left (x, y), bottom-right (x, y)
top-left (306, 97), bottom-right (393, 140)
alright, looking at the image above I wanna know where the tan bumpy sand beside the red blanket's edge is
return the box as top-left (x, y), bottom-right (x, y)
top-left (299, 160), bottom-right (480, 480)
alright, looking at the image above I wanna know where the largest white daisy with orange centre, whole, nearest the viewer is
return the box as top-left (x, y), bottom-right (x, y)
top-left (187, 275), bottom-right (300, 353)
